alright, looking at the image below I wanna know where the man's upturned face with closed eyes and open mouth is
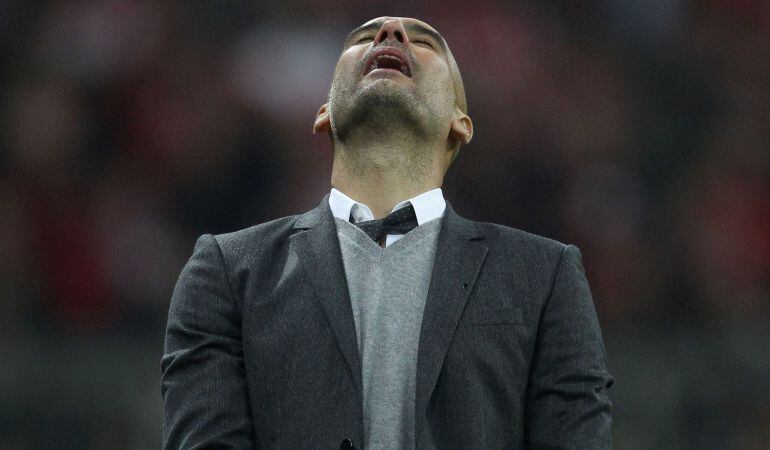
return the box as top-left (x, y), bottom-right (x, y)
top-left (316, 17), bottom-right (470, 145)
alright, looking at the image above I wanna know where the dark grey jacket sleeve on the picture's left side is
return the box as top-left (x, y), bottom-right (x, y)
top-left (161, 234), bottom-right (254, 449)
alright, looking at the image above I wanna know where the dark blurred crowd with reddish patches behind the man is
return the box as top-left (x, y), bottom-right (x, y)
top-left (0, 0), bottom-right (770, 450)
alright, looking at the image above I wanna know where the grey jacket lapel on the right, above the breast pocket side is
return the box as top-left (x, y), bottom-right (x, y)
top-left (415, 201), bottom-right (489, 418)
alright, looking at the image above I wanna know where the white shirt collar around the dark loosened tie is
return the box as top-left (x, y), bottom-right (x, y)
top-left (329, 188), bottom-right (446, 247)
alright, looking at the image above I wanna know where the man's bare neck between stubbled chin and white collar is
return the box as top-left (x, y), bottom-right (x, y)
top-left (331, 141), bottom-right (448, 219)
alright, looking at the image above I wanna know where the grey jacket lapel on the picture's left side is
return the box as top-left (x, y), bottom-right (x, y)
top-left (289, 194), bottom-right (363, 393)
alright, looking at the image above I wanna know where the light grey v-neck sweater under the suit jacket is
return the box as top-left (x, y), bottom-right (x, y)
top-left (332, 217), bottom-right (441, 449)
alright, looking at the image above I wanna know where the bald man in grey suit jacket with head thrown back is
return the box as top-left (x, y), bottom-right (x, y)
top-left (161, 17), bottom-right (613, 449)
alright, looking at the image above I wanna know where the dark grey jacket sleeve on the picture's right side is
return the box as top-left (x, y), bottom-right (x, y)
top-left (526, 245), bottom-right (614, 450)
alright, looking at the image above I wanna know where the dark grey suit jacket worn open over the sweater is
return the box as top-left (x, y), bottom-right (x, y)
top-left (161, 194), bottom-right (613, 449)
